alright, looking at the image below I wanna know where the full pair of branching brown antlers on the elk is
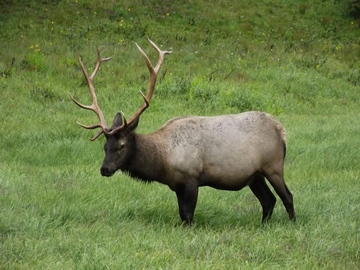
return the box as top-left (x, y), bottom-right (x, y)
top-left (70, 38), bottom-right (172, 141)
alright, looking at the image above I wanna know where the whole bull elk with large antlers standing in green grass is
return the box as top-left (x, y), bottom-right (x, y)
top-left (71, 38), bottom-right (295, 225)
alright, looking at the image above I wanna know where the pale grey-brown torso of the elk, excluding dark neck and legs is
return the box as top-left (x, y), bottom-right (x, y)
top-left (125, 112), bottom-right (286, 190)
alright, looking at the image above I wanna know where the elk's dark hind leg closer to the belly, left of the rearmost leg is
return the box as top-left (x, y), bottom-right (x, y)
top-left (249, 174), bottom-right (276, 223)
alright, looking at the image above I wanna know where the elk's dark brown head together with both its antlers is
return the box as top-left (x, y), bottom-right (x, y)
top-left (71, 38), bottom-right (171, 176)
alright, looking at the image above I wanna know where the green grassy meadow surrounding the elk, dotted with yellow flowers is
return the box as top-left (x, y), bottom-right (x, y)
top-left (0, 0), bottom-right (360, 270)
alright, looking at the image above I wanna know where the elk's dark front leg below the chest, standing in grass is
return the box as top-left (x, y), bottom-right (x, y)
top-left (175, 184), bottom-right (198, 225)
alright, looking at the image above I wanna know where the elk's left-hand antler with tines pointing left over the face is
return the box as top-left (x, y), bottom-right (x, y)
top-left (70, 49), bottom-right (111, 141)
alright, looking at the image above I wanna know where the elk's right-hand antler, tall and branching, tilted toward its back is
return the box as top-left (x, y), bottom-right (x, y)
top-left (122, 38), bottom-right (172, 123)
